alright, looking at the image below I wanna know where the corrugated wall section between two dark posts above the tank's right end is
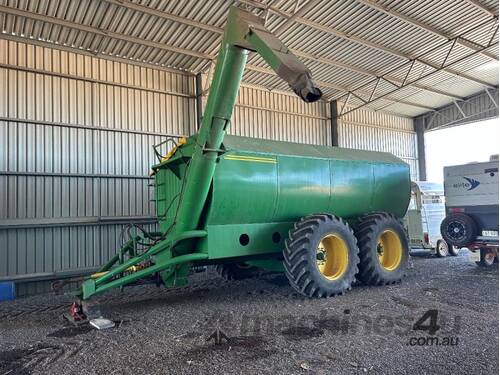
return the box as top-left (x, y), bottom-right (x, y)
top-left (338, 103), bottom-right (418, 181)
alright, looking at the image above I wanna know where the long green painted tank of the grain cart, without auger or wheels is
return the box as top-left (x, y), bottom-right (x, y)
top-left (154, 135), bottom-right (410, 259)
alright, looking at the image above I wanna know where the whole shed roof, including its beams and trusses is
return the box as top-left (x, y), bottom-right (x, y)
top-left (0, 0), bottom-right (498, 117)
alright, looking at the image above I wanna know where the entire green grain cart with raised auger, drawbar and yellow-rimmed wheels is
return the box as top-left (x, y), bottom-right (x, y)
top-left (79, 7), bottom-right (410, 306)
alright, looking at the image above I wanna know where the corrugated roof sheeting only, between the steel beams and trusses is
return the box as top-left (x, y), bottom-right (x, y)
top-left (0, 0), bottom-right (498, 115)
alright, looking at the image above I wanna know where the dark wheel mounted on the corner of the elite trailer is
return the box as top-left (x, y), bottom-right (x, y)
top-left (441, 212), bottom-right (477, 248)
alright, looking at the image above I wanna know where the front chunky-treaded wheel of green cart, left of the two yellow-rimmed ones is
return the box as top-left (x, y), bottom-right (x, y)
top-left (283, 214), bottom-right (359, 297)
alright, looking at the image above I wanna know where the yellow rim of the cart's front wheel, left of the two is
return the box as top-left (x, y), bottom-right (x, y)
top-left (316, 233), bottom-right (349, 280)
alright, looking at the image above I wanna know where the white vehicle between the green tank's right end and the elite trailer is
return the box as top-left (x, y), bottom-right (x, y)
top-left (404, 181), bottom-right (460, 257)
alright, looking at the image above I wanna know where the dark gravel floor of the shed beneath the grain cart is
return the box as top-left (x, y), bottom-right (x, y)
top-left (0, 251), bottom-right (498, 374)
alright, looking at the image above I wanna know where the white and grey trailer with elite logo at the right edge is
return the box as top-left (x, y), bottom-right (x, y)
top-left (441, 155), bottom-right (498, 266)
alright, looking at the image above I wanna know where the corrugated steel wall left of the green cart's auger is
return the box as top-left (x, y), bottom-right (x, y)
top-left (0, 40), bottom-right (196, 295)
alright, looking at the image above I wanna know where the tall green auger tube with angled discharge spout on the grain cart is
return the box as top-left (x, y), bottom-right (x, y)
top-left (173, 7), bottom-right (321, 241)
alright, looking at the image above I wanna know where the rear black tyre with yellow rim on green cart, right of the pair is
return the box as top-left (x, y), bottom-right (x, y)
top-left (356, 213), bottom-right (408, 285)
